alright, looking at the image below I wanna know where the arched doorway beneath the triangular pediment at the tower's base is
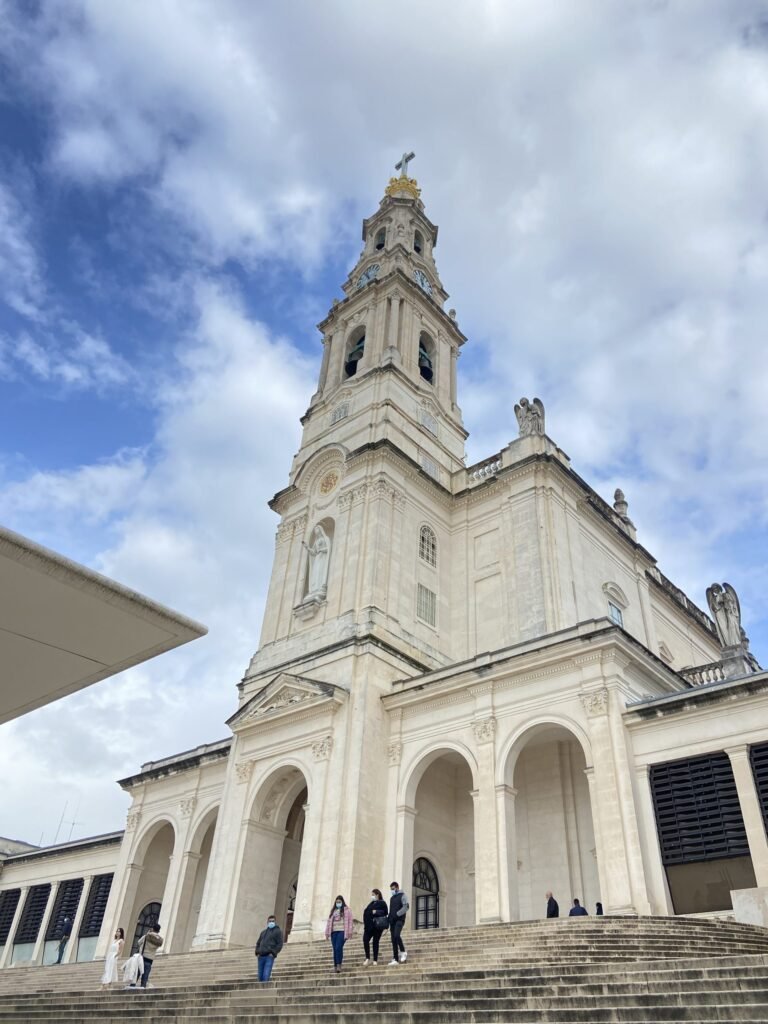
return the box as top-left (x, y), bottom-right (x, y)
top-left (230, 765), bottom-right (307, 945)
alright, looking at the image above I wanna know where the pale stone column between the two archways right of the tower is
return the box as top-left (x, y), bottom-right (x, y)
top-left (472, 716), bottom-right (502, 925)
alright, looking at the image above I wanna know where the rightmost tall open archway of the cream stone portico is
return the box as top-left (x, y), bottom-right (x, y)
top-left (507, 723), bottom-right (600, 921)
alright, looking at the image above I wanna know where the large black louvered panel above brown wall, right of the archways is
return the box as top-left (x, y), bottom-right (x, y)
top-left (650, 753), bottom-right (750, 864)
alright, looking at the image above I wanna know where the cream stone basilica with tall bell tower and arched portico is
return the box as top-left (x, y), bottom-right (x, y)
top-left (0, 169), bottom-right (768, 965)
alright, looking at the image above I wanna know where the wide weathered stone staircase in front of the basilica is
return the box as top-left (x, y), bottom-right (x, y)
top-left (0, 918), bottom-right (768, 1024)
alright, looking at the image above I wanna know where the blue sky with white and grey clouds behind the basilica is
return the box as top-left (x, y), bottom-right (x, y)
top-left (0, 0), bottom-right (768, 843)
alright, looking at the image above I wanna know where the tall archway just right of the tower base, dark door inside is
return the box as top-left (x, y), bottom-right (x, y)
top-left (403, 749), bottom-right (475, 928)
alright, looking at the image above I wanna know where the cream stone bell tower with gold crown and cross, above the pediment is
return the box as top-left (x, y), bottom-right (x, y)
top-left (246, 154), bottom-right (467, 671)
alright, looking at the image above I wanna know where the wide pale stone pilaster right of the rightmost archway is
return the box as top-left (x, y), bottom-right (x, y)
top-left (582, 686), bottom-right (650, 914)
